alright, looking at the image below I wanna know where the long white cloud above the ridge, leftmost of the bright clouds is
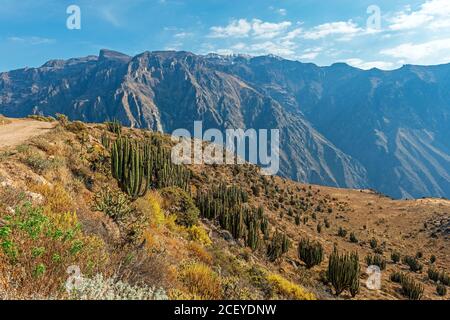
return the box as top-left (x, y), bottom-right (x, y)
top-left (209, 19), bottom-right (291, 39)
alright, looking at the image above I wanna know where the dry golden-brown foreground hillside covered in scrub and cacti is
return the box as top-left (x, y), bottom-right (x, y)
top-left (0, 117), bottom-right (450, 299)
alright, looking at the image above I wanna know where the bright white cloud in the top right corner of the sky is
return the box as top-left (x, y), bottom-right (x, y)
top-left (389, 0), bottom-right (450, 31)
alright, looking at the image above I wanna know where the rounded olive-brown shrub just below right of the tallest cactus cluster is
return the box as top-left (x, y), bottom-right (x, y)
top-left (161, 187), bottom-right (200, 227)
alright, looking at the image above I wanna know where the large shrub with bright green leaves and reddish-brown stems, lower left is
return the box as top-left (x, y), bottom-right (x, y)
top-left (0, 203), bottom-right (108, 296)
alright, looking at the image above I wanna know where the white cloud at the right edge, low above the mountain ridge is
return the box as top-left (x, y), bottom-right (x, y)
top-left (380, 38), bottom-right (450, 64)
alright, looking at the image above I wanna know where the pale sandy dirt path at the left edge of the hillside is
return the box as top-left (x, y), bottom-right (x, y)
top-left (0, 119), bottom-right (55, 148)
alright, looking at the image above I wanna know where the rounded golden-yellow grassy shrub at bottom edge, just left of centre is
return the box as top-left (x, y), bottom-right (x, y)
top-left (179, 263), bottom-right (222, 300)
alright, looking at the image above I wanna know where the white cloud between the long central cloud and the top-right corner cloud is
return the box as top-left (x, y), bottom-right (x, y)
top-left (303, 20), bottom-right (364, 40)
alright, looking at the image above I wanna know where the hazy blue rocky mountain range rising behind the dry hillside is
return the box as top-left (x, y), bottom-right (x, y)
top-left (0, 50), bottom-right (450, 198)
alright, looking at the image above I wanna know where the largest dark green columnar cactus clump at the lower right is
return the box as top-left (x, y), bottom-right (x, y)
top-left (327, 247), bottom-right (360, 296)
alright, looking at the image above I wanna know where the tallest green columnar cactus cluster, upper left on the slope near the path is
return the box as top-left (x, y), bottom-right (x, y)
top-left (111, 136), bottom-right (190, 199)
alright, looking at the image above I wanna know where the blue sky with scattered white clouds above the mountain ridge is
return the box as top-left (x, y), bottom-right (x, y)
top-left (0, 0), bottom-right (450, 71)
